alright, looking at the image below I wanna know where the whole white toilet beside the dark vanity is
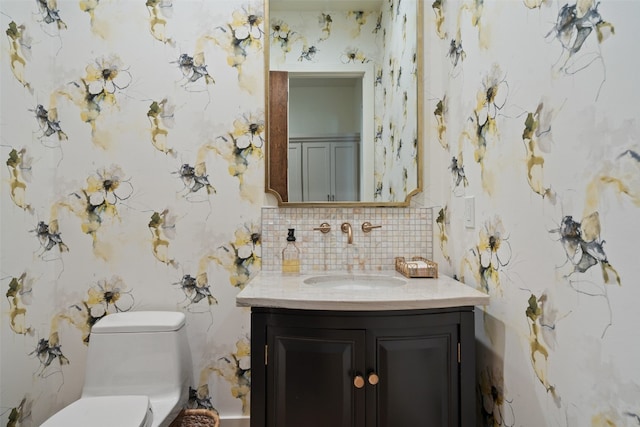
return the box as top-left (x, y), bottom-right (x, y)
top-left (42, 311), bottom-right (192, 427)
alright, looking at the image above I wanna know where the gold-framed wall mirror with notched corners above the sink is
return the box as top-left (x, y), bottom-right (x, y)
top-left (265, 0), bottom-right (423, 206)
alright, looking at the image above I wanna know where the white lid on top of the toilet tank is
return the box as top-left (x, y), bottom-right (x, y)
top-left (91, 311), bottom-right (185, 334)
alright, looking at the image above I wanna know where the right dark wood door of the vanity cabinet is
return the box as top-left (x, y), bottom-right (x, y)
top-left (367, 323), bottom-right (459, 427)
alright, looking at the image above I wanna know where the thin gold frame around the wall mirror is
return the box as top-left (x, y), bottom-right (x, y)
top-left (264, 0), bottom-right (424, 207)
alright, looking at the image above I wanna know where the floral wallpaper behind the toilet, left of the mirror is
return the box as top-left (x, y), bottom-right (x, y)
top-left (0, 0), bottom-right (265, 426)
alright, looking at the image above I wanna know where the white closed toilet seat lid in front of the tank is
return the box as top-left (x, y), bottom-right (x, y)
top-left (41, 396), bottom-right (153, 427)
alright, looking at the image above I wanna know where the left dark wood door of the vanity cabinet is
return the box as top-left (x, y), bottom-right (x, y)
top-left (266, 326), bottom-right (365, 427)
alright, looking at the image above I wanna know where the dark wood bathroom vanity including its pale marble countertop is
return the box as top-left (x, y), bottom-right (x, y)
top-left (237, 272), bottom-right (489, 427)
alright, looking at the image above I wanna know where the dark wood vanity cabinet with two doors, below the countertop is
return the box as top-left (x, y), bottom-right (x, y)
top-left (251, 307), bottom-right (475, 427)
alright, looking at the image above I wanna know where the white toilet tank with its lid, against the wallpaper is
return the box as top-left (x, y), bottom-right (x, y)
top-left (82, 311), bottom-right (192, 398)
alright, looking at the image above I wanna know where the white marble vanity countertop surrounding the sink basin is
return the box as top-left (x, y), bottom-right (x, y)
top-left (236, 271), bottom-right (489, 310)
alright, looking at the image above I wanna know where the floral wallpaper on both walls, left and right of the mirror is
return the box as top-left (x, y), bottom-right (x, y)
top-left (0, 0), bottom-right (640, 426)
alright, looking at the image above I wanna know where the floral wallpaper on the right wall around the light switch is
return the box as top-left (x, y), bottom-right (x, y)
top-left (425, 0), bottom-right (640, 427)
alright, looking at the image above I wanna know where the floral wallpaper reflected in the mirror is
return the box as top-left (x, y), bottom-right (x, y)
top-left (269, 0), bottom-right (418, 202)
